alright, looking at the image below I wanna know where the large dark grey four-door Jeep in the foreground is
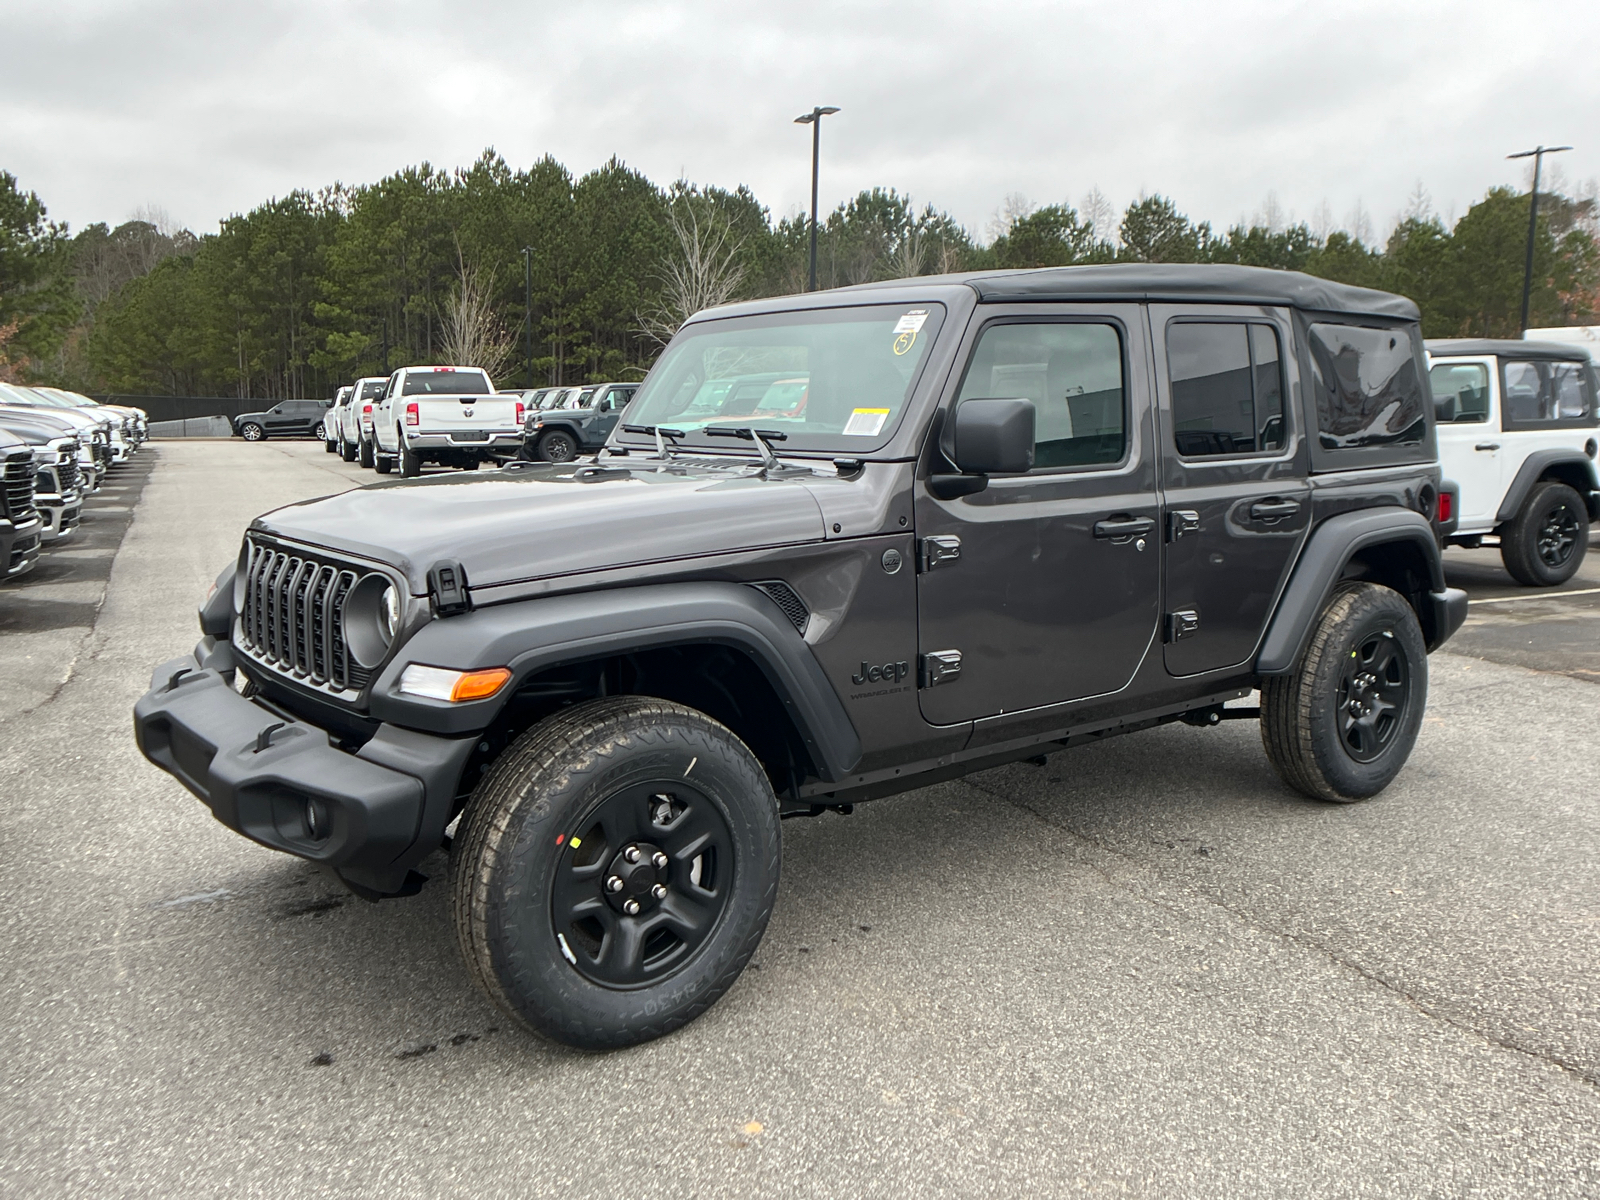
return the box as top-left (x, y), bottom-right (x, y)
top-left (134, 266), bottom-right (1466, 1046)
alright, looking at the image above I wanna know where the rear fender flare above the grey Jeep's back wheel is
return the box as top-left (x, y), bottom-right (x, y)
top-left (1256, 506), bottom-right (1464, 675)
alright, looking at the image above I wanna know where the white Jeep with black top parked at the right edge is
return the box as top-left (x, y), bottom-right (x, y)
top-left (1427, 338), bottom-right (1600, 587)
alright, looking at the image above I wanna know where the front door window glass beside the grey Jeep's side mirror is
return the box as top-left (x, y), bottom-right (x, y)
top-left (955, 322), bottom-right (1128, 469)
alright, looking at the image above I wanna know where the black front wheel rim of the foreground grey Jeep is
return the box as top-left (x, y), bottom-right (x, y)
top-left (550, 782), bottom-right (734, 990)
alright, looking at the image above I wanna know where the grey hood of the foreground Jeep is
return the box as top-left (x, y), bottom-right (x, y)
top-left (251, 458), bottom-right (824, 595)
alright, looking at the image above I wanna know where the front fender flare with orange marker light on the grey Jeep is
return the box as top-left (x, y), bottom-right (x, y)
top-left (370, 582), bottom-right (861, 782)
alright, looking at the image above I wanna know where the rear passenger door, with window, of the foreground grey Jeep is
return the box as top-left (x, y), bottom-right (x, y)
top-left (1150, 304), bottom-right (1310, 675)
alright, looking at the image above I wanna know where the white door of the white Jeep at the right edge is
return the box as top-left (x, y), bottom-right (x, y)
top-left (1427, 358), bottom-right (1510, 533)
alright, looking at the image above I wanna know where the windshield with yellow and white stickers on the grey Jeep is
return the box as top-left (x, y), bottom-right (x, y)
top-left (611, 304), bottom-right (944, 453)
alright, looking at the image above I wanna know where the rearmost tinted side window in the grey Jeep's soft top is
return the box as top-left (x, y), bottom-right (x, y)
top-left (1310, 323), bottom-right (1427, 450)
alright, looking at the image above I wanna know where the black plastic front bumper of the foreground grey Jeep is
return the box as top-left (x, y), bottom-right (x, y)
top-left (133, 654), bottom-right (477, 899)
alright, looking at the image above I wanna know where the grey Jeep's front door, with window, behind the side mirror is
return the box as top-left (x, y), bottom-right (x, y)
top-left (917, 304), bottom-right (1160, 725)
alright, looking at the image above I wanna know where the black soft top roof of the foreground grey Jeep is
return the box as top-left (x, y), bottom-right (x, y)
top-left (830, 262), bottom-right (1421, 322)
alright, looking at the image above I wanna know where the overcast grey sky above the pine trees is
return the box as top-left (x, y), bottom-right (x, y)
top-left (0, 0), bottom-right (1600, 244)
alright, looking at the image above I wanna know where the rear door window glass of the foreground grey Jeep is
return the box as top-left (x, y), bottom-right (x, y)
top-left (1166, 322), bottom-right (1285, 458)
